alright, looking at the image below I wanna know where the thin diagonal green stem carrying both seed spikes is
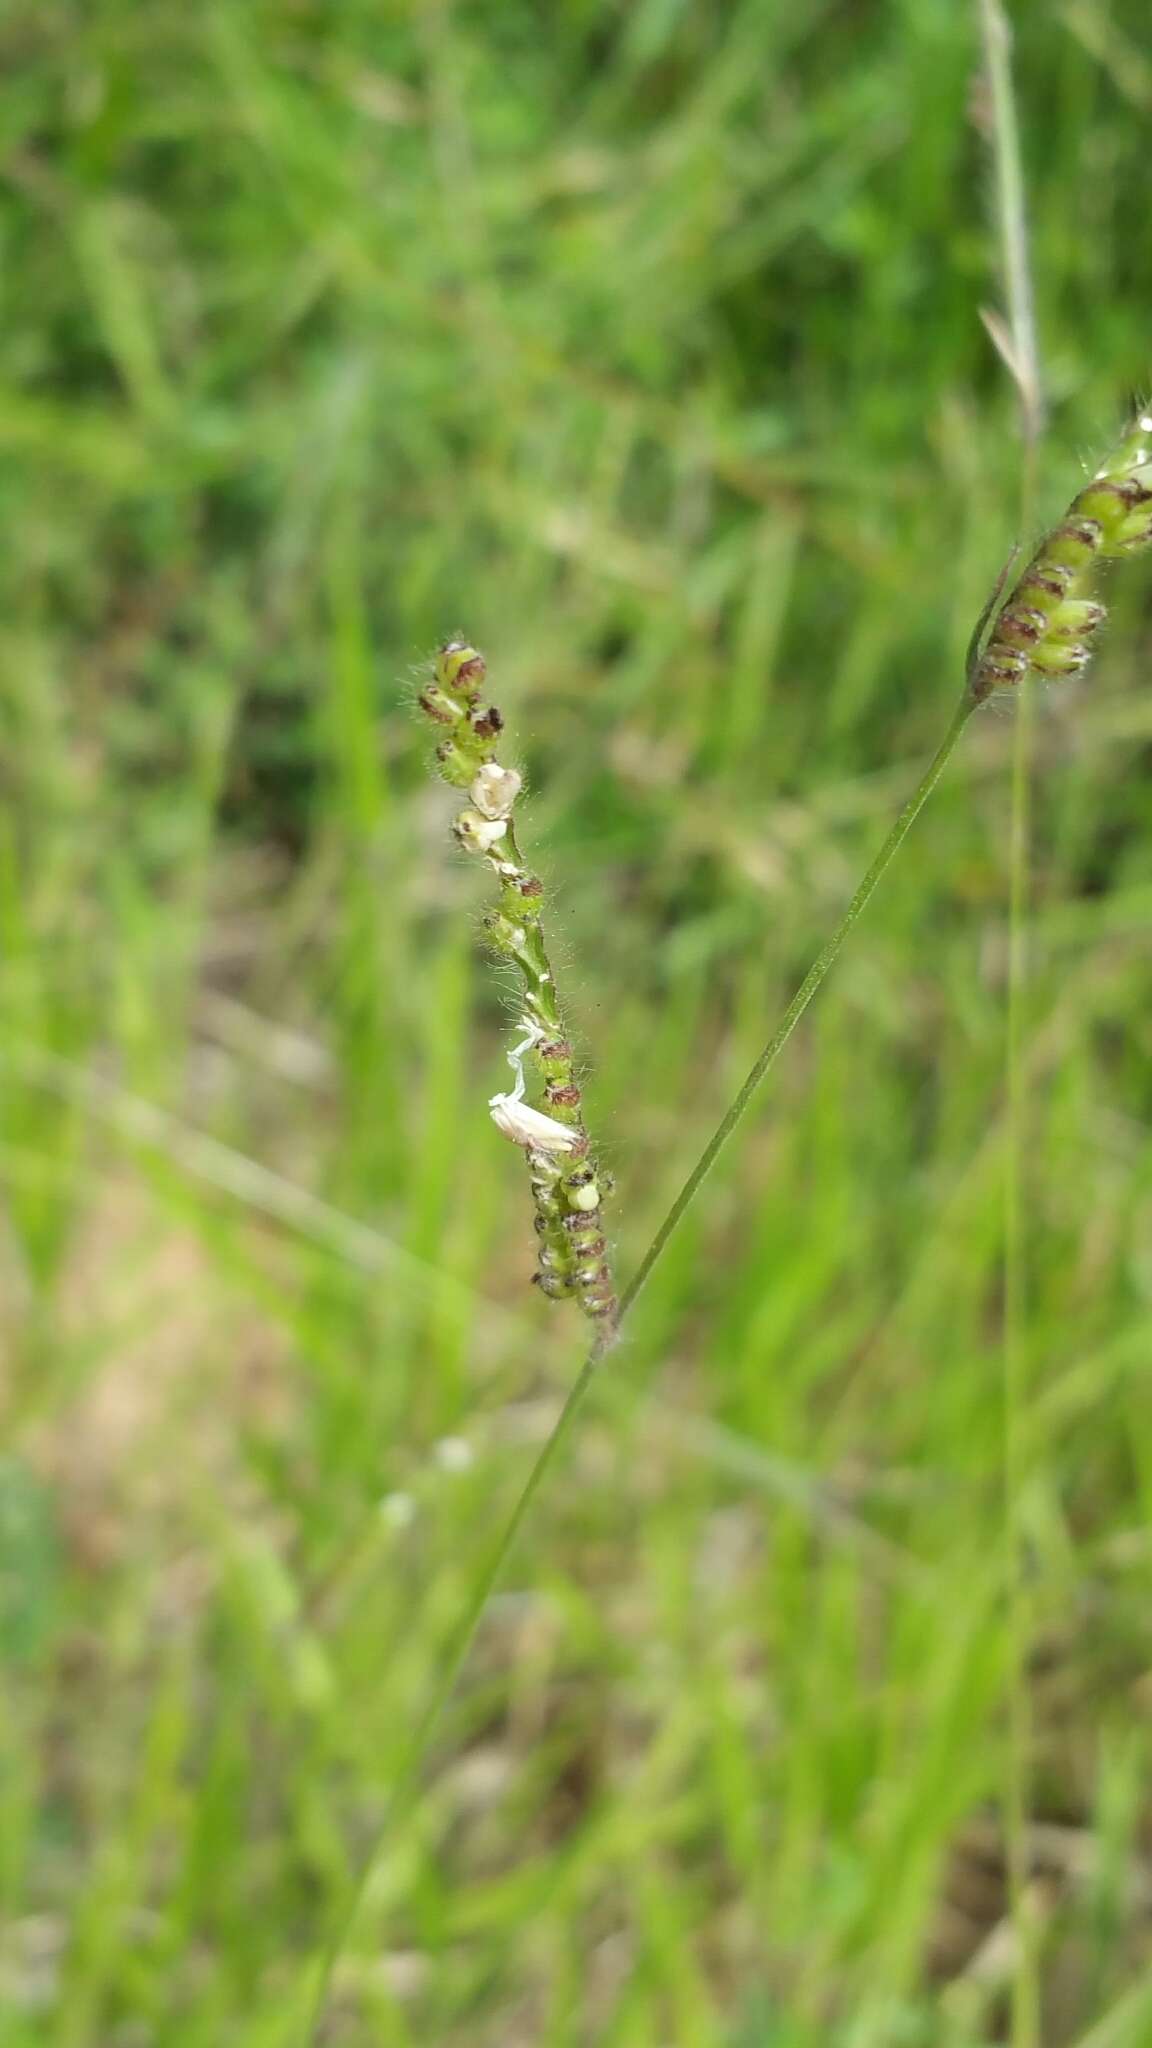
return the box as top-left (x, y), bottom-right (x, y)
top-left (307, 686), bottom-right (976, 2042)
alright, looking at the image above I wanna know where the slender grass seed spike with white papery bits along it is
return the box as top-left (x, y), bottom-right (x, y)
top-left (418, 641), bottom-right (617, 1343)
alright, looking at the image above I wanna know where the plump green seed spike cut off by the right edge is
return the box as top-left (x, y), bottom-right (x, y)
top-left (968, 414), bottom-right (1152, 705)
